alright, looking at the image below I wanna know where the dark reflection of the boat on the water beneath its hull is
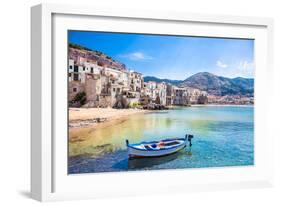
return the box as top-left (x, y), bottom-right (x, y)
top-left (128, 149), bottom-right (191, 170)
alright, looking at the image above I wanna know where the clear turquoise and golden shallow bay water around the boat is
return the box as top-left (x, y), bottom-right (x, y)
top-left (68, 106), bottom-right (254, 174)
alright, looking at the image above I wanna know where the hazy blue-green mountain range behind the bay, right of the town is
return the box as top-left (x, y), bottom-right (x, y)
top-left (144, 72), bottom-right (254, 96)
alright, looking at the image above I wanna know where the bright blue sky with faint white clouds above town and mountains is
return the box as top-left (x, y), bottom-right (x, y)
top-left (68, 31), bottom-right (254, 80)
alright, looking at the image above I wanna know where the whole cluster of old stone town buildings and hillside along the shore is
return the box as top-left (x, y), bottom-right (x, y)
top-left (68, 45), bottom-right (207, 107)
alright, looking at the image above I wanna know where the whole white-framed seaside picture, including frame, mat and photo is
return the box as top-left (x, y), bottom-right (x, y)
top-left (31, 4), bottom-right (273, 201)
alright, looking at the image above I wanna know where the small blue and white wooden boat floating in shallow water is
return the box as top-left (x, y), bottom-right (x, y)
top-left (126, 135), bottom-right (193, 158)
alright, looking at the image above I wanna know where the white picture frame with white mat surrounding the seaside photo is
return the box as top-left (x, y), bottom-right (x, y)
top-left (31, 4), bottom-right (274, 201)
